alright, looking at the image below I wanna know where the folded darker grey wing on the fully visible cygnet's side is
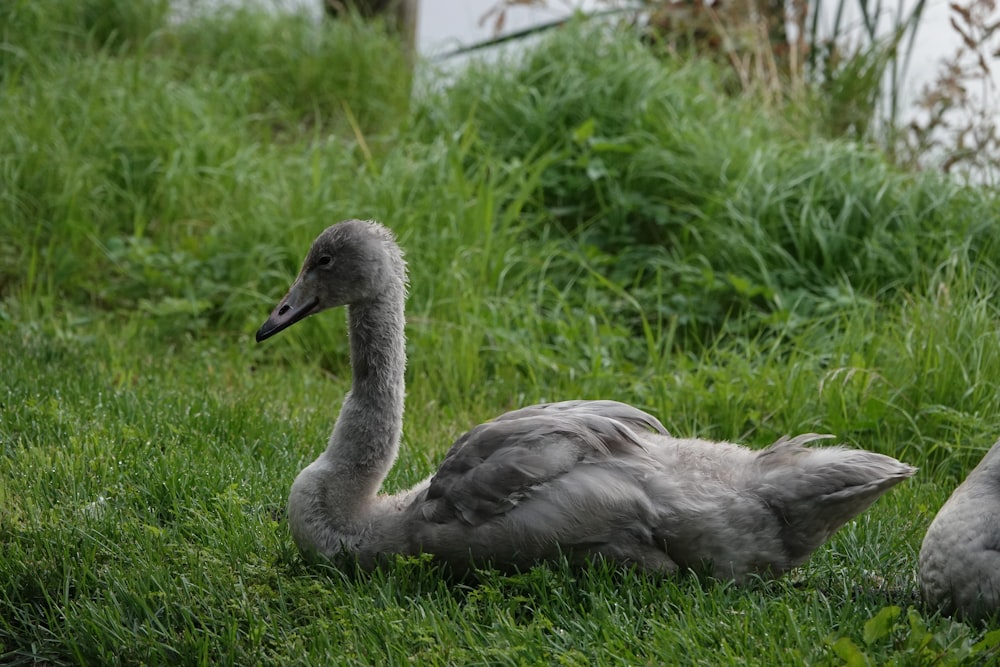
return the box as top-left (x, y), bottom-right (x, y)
top-left (422, 401), bottom-right (666, 526)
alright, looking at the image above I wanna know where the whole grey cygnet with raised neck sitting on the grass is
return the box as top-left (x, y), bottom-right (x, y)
top-left (256, 220), bottom-right (916, 582)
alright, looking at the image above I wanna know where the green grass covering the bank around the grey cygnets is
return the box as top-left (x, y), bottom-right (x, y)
top-left (0, 0), bottom-right (1000, 665)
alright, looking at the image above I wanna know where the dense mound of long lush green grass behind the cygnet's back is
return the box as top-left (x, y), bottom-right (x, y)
top-left (427, 30), bottom-right (997, 344)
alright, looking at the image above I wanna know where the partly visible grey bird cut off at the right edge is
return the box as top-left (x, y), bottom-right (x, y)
top-left (918, 441), bottom-right (1000, 621)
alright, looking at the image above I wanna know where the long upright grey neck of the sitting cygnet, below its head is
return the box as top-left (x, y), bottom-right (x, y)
top-left (320, 285), bottom-right (406, 521)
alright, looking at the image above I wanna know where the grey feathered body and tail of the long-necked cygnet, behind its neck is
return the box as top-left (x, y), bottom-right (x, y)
top-left (388, 404), bottom-right (914, 580)
